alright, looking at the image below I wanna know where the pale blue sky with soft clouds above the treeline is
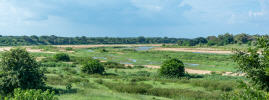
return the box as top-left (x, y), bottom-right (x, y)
top-left (0, 0), bottom-right (269, 38)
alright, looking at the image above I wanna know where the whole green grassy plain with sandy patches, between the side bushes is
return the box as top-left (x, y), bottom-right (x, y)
top-left (1, 44), bottom-right (245, 100)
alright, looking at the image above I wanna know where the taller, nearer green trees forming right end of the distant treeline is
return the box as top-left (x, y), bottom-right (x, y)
top-left (177, 33), bottom-right (264, 46)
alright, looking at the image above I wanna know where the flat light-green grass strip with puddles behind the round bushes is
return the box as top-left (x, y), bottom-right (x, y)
top-left (74, 47), bottom-right (236, 72)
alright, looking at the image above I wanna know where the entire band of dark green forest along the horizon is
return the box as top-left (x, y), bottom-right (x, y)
top-left (0, 33), bottom-right (268, 46)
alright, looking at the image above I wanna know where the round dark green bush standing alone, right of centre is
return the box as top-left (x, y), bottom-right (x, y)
top-left (159, 58), bottom-right (185, 77)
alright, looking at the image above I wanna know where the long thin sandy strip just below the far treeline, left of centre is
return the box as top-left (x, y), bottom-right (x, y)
top-left (54, 44), bottom-right (162, 48)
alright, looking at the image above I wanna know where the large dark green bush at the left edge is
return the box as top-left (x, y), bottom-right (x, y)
top-left (0, 48), bottom-right (46, 94)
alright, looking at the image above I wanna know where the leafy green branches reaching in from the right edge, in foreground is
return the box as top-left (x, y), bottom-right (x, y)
top-left (233, 38), bottom-right (269, 91)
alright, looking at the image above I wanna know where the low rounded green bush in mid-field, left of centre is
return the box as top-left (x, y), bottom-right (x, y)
top-left (81, 60), bottom-right (105, 74)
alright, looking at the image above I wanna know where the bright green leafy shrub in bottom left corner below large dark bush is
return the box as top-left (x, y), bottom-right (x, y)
top-left (5, 89), bottom-right (58, 100)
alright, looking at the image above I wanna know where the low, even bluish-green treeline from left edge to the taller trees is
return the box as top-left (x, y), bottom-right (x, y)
top-left (0, 35), bottom-right (187, 46)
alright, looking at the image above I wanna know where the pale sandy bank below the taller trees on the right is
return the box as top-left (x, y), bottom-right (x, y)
top-left (153, 48), bottom-right (233, 54)
